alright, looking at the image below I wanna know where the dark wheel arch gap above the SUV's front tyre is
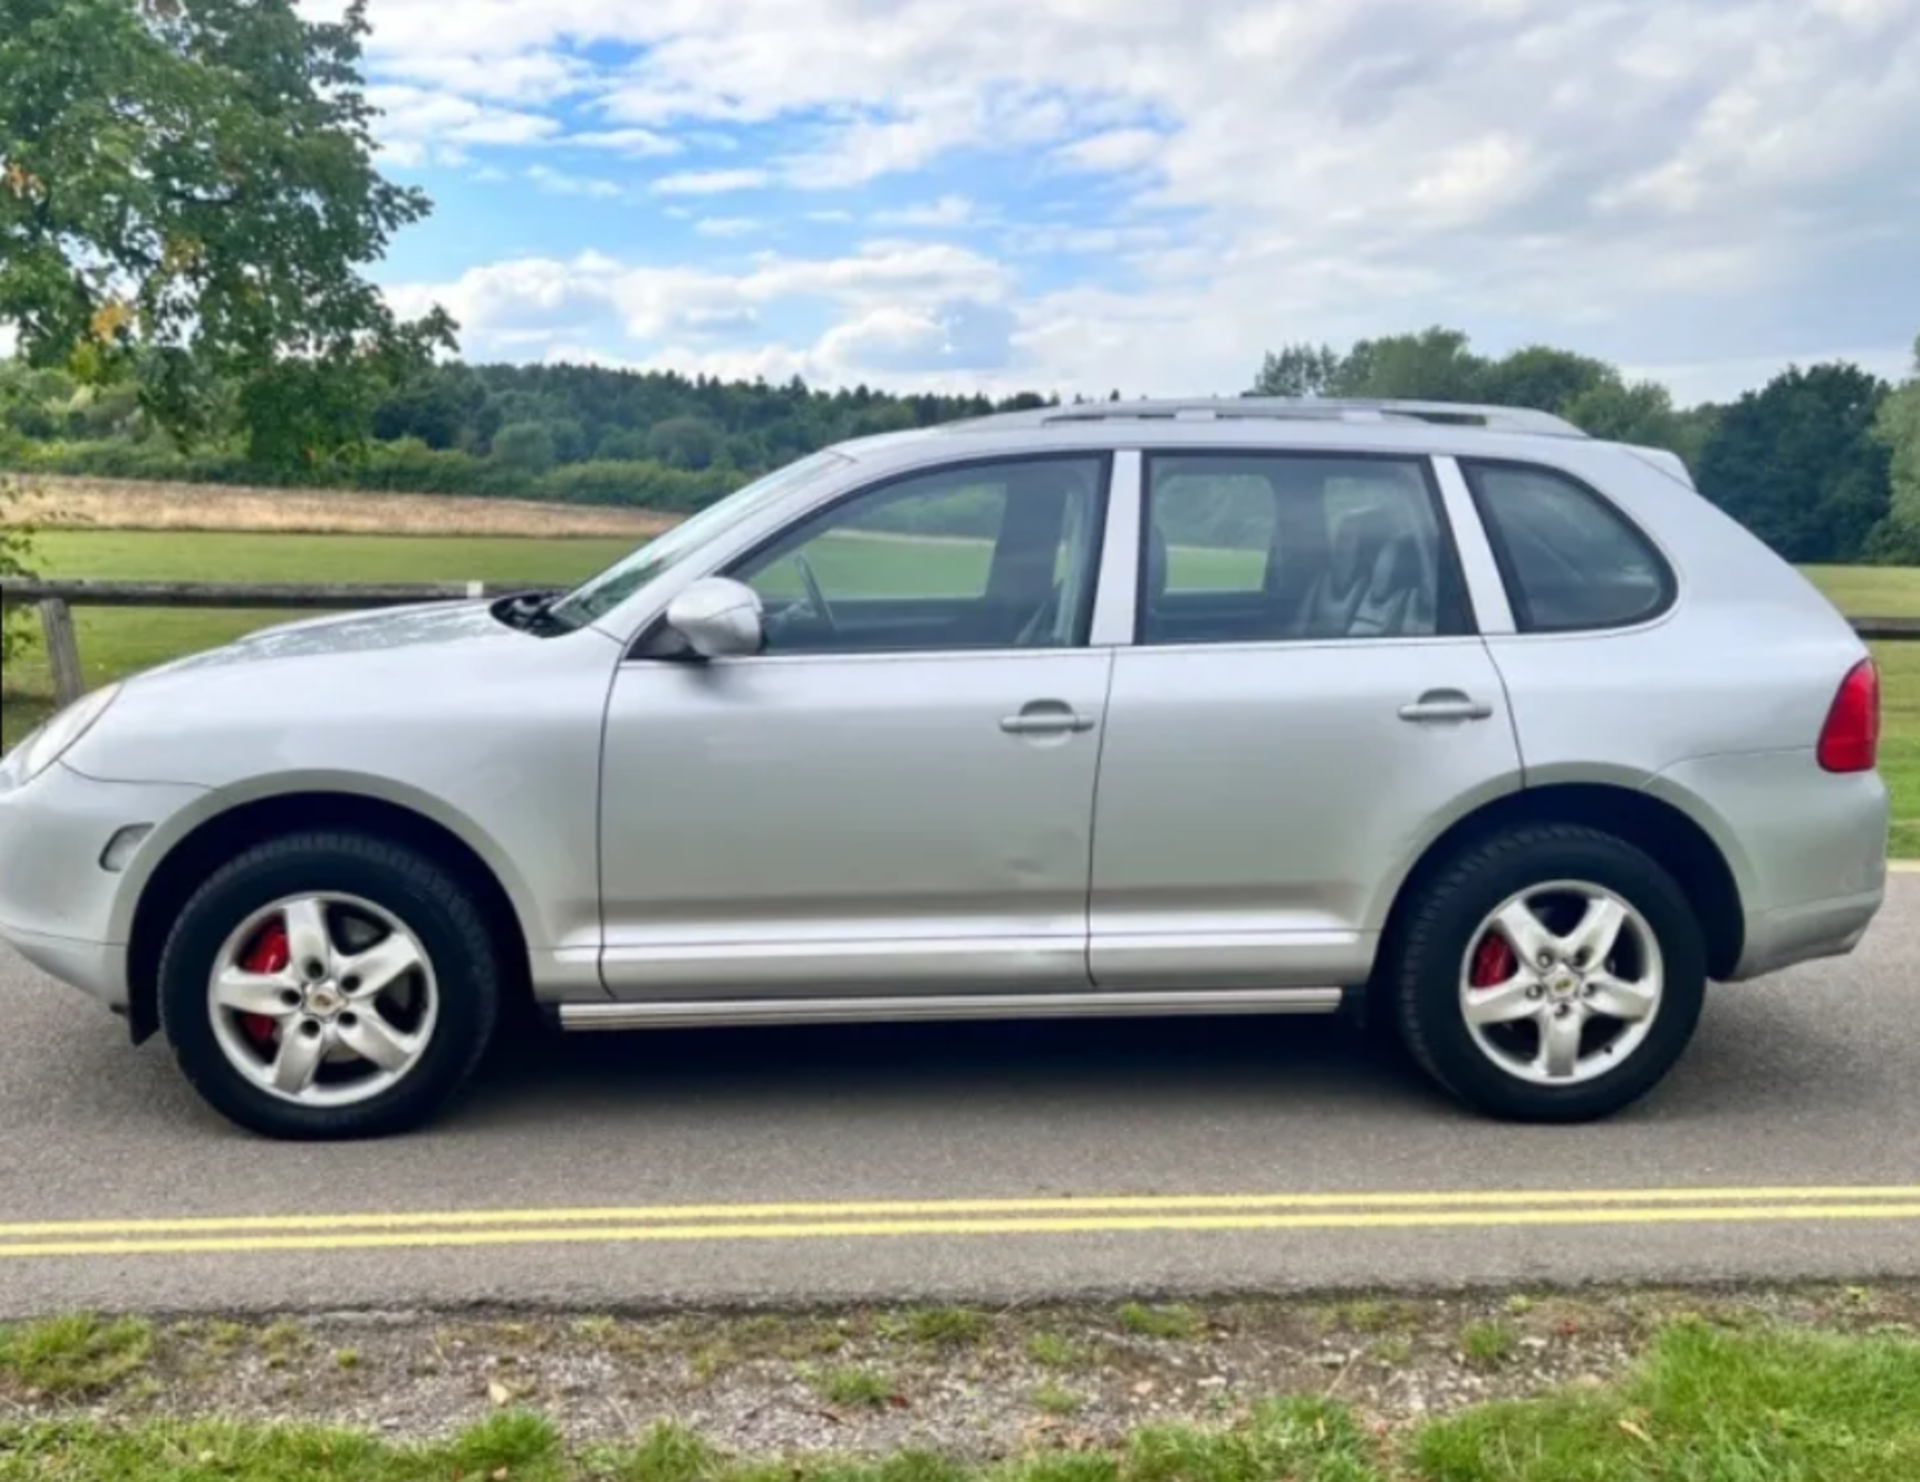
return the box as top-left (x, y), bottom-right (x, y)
top-left (125, 779), bottom-right (532, 1044)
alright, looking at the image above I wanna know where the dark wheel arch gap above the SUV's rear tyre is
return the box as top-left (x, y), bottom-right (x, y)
top-left (1380, 781), bottom-right (1747, 977)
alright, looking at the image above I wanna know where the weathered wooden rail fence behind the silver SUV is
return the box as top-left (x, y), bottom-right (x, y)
top-left (0, 582), bottom-right (1920, 705)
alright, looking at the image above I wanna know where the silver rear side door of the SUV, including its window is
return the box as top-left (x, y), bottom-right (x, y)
top-left (1091, 451), bottom-right (1521, 989)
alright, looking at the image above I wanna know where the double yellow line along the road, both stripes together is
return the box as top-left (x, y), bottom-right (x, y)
top-left (0, 1184), bottom-right (1920, 1261)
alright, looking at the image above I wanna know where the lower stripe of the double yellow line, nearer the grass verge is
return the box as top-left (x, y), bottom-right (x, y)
top-left (0, 1204), bottom-right (1920, 1259)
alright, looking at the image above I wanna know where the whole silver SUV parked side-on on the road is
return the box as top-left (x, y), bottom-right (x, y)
top-left (0, 399), bottom-right (1887, 1136)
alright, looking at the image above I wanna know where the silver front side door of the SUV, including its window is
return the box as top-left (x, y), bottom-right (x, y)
top-left (601, 457), bottom-right (1112, 1000)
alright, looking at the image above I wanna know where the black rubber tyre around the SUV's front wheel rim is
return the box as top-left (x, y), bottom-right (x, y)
top-left (159, 831), bottom-right (501, 1140)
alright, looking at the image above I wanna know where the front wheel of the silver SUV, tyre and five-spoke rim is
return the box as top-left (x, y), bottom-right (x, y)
top-left (159, 833), bottom-right (501, 1138)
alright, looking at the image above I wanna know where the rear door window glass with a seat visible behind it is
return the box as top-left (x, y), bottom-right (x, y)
top-left (1139, 453), bottom-right (1467, 645)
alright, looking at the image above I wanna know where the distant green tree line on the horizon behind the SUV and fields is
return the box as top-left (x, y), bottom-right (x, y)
top-left (0, 328), bottom-right (1920, 562)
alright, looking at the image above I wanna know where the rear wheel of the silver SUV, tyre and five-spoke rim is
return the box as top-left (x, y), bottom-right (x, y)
top-left (1380, 825), bottom-right (1707, 1121)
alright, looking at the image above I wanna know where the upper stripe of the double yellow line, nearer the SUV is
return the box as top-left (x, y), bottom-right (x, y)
top-left (0, 1184), bottom-right (1920, 1242)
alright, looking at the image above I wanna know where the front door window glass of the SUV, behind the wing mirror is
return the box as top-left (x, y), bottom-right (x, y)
top-left (733, 459), bottom-right (1104, 655)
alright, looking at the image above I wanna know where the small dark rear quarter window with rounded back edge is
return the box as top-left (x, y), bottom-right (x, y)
top-left (1461, 459), bottom-right (1674, 633)
